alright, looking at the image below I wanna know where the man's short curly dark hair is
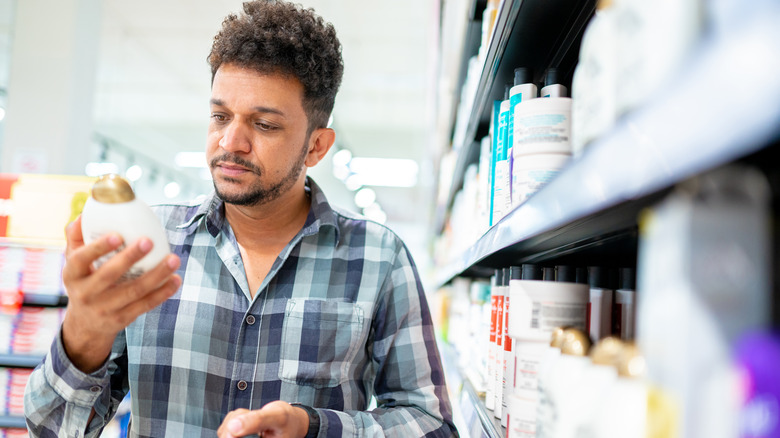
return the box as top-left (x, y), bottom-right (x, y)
top-left (208, 0), bottom-right (344, 132)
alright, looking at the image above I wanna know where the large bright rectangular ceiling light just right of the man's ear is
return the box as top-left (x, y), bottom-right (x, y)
top-left (349, 157), bottom-right (419, 187)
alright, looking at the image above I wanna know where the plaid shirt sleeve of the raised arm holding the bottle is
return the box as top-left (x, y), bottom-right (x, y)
top-left (24, 331), bottom-right (128, 437)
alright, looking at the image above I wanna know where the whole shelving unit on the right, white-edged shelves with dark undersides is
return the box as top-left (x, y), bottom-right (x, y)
top-left (433, 0), bottom-right (780, 437)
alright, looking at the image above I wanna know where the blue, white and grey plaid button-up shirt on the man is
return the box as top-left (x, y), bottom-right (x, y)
top-left (25, 179), bottom-right (457, 437)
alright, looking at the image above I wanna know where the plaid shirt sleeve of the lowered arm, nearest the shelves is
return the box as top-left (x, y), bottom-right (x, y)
top-left (316, 244), bottom-right (458, 438)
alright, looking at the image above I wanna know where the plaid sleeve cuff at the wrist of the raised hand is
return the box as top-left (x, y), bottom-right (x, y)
top-left (43, 330), bottom-right (110, 409)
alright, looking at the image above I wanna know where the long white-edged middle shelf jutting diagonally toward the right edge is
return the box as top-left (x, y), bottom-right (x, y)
top-left (437, 20), bottom-right (780, 285)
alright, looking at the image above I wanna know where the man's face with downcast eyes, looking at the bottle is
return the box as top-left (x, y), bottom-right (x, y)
top-left (206, 64), bottom-right (309, 205)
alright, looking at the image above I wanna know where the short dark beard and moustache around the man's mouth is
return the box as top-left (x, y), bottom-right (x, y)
top-left (215, 138), bottom-right (309, 206)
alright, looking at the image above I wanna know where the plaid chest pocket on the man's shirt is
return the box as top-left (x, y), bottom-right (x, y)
top-left (279, 299), bottom-right (368, 388)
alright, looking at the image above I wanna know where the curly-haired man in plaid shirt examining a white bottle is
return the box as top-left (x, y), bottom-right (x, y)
top-left (25, 1), bottom-right (456, 438)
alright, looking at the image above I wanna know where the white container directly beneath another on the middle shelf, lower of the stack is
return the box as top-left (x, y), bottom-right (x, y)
top-left (512, 154), bottom-right (570, 206)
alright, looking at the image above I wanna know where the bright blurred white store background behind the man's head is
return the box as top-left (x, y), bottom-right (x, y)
top-left (0, 0), bottom-right (439, 278)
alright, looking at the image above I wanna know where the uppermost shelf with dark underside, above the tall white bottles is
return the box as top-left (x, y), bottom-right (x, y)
top-left (434, 0), bottom-right (595, 232)
